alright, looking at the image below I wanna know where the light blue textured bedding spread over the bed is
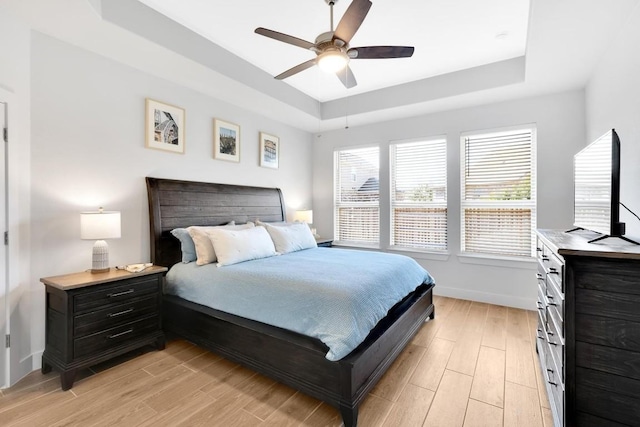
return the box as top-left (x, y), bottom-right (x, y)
top-left (165, 248), bottom-right (433, 360)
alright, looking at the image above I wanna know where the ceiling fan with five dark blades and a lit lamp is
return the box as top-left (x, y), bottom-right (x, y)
top-left (255, 0), bottom-right (414, 88)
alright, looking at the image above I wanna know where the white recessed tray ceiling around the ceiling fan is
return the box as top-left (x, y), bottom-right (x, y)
top-left (0, 0), bottom-right (640, 132)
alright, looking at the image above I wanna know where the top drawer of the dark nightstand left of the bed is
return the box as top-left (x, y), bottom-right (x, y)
top-left (73, 277), bottom-right (158, 313)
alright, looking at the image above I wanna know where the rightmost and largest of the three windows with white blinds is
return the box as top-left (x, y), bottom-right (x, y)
top-left (461, 127), bottom-right (536, 257)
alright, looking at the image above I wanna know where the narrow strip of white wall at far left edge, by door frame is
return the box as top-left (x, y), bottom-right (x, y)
top-left (0, 5), bottom-right (32, 387)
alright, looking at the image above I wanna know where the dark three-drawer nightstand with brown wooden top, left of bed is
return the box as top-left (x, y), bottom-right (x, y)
top-left (40, 266), bottom-right (167, 390)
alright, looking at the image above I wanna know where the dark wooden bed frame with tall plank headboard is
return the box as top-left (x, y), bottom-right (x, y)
top-left (146, 178), bottom-right (434, 427)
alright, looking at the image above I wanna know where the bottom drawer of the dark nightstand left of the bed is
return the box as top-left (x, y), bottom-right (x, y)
top-left (73, 314), bottom-right (160, 358)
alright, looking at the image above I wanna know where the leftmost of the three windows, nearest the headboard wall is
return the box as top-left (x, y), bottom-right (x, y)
top-left (334, 147), bottom-right (380, 246)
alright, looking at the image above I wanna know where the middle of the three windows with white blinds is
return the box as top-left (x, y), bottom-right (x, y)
top-left (389, 138), bottom-right (447, 251)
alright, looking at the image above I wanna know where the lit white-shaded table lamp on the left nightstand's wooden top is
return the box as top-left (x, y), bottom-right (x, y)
top-left (80, 208), bottom-right (120, 273)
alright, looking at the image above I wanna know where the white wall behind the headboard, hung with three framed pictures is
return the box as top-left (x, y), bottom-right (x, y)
top-left (31, 33), bottom-right (311, 368)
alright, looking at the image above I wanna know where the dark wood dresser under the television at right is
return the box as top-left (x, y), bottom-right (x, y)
top-left (536, 230), bottom-right (640, 427)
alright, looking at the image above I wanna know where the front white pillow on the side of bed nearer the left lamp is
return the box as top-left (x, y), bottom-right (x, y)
top-left (208, 227), bottom-right (277, 267)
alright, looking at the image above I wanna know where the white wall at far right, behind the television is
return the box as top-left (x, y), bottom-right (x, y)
top-left (585, 2), bottom-right (640, 241)
